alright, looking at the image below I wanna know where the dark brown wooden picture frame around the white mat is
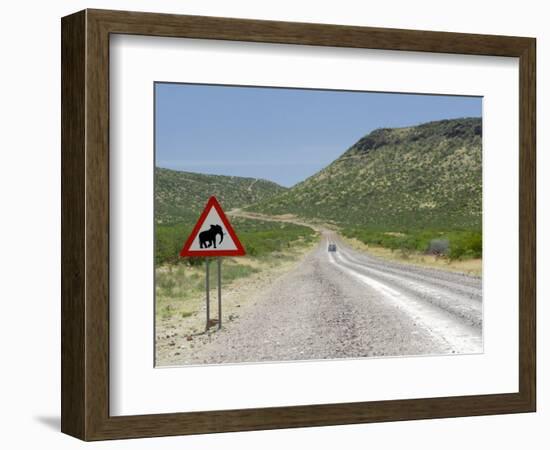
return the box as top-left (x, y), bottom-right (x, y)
top-left (61, 10), bottom-right (536, 440)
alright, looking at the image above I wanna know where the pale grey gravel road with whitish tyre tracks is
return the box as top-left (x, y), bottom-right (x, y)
top-left (169, 231), bottom-right (483, 365)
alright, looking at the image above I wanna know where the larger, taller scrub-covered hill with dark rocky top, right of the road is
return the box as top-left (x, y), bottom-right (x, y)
top-left (247, 118), bottom-right (482, 230)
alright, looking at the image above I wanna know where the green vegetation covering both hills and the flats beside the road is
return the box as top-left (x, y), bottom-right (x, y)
top-left (155, 118), bottom-right (482, 266)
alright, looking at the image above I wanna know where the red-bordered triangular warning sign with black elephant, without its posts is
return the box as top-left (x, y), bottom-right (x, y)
top-left (180, 196), bottom-right (246, 256)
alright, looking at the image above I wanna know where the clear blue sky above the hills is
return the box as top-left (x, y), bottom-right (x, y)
top-left (155, 83), bottom-right (482, 186)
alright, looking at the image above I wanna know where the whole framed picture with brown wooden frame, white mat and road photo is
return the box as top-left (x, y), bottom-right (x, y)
top-left (61, 10), bottom-right (536, 440)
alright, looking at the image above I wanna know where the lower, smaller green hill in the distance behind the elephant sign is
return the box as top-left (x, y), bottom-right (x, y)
top-left (155, 167), bottom-right (286, 224)
